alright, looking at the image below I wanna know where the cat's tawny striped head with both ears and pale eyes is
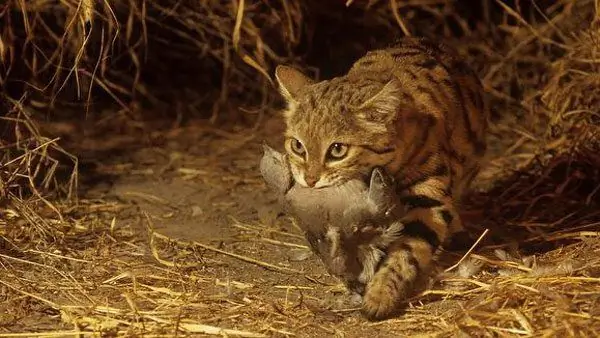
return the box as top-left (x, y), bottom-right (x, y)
top-left (275, 66), bottom-right (401, 188)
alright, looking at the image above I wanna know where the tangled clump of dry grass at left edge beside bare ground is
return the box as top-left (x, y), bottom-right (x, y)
top-left (0, 100), bottom-right (78, 247)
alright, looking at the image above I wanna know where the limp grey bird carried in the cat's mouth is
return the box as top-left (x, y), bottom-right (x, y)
top-left (260, 145), bottom-right (404, 295)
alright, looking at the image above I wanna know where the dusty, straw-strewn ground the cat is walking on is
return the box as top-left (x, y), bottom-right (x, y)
top-left (0, 103), bottom-right (600, 337)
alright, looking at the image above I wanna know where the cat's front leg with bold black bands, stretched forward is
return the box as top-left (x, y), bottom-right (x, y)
top-left (362, 170), bottom-right (462, 320)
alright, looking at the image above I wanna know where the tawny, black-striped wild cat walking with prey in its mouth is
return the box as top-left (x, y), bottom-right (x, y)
top-left (275, 37), bottom-right (489, 319)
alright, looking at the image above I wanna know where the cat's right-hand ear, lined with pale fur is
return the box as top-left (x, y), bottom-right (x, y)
top-left (357, 79), bottom-right (401, 125)
